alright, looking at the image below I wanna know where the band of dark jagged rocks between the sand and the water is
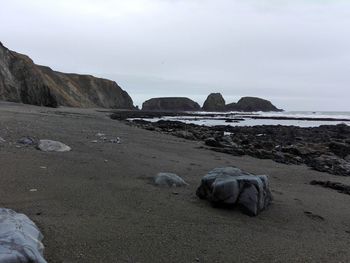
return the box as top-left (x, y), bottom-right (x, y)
top-left (117, 114), bottom-right (350, 176)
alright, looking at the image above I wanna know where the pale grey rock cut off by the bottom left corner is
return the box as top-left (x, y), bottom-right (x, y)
top-left (0, 208), bottom-right (46, 263)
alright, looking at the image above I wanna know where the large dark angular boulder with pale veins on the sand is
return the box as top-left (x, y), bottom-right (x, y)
top-left (196, 167), bottom-right (272, 216)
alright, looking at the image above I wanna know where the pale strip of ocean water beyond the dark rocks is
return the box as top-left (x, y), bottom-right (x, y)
top-left (131, 111), bottom-right (350, 127)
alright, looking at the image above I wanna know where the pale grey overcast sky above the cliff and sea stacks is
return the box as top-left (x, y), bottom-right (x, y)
top-left (0, 0), bottom-right (350, 111)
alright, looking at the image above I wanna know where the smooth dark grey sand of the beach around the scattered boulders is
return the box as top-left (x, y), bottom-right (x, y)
top-left (0, 103), bottom-right (350, 263)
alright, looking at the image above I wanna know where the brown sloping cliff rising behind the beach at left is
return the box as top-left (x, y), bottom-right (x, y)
top-left (0, 42), bottom-right (133, 109)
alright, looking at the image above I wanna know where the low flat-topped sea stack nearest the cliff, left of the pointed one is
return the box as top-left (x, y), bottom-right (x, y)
top-left (142, 97), bottom-right (201, 111)
